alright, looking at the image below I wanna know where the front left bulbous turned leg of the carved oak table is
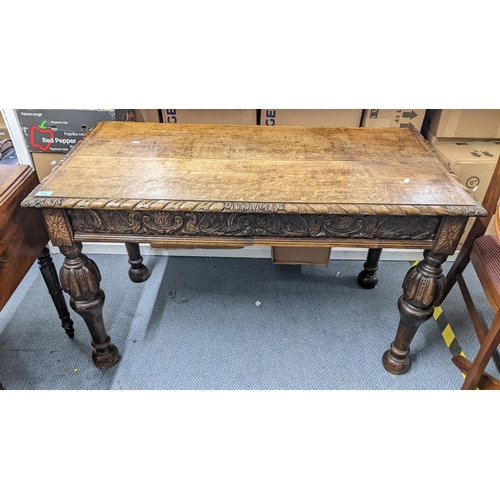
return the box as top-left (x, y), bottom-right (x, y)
top-left (59, 243), bottom-right (120, 368)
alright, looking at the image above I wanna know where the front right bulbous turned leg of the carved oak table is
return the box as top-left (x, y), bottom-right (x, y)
top-left (382, 250), bottom-right (447, 375)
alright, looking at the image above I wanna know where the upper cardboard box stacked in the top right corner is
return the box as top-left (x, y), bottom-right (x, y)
top-left (422, 109), bottom-right (500, 141)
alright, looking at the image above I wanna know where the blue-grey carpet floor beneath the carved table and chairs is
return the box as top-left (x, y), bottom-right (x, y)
top-left (0, 254), bottom-right (499, 390)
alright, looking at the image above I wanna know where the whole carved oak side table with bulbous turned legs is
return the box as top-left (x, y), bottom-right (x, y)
top-left (23, 122), bottom-right (486, 374)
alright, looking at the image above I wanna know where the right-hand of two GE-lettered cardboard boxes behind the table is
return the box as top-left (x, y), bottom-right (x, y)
top-left (260, 109), bottom-right (363, 127)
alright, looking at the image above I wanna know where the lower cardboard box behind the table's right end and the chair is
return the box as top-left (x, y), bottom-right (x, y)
top-left (432, 141), bottom-right (500, 248)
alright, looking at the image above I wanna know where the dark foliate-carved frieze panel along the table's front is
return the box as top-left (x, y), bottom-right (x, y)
top-left (69, 210), bottom-right (440, 240)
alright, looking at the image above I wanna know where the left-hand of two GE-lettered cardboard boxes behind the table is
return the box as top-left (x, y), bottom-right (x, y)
top-left (161, 109), bottom-right (257, 125)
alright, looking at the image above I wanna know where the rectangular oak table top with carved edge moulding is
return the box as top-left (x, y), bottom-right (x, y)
top-left (23, 122), bottom-right (484, 216)
